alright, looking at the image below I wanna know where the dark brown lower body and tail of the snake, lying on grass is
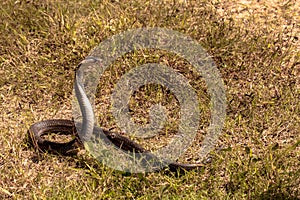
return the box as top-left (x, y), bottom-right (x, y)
top-left (29, 119), bottom-right (203, 172)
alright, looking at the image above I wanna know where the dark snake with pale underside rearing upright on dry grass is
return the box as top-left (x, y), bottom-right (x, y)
top-left (28, 61), bottom-right (204, 172)
